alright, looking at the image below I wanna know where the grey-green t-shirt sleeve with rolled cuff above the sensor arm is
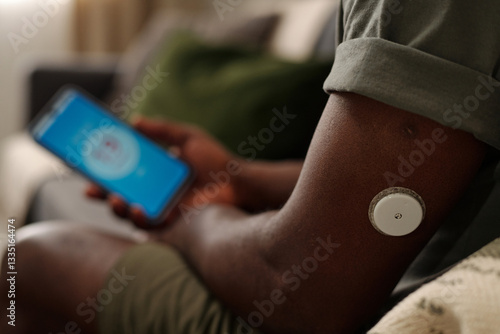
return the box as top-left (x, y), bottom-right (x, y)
top-left (324, 0), bottom-right (500, 149)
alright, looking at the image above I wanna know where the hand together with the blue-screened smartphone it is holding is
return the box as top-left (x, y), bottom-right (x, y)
top-left (30, 88), bottom-right (241, 228)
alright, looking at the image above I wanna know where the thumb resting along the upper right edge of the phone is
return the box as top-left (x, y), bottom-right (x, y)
top-left (132, 118), bottom-right (194, 146)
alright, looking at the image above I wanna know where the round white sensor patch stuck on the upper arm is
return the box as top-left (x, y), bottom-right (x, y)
top-left (368, 187), bottom-right (425, 237)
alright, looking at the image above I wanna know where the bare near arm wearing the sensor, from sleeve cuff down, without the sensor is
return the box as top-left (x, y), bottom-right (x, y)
top-left (165, 93), bottom-right (484, 333)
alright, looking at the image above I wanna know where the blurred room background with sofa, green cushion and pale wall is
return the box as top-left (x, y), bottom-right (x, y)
top-left (0, 0), bottom-right (339, 258)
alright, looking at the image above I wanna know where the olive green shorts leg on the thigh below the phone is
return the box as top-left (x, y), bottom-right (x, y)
top-left (99, 243), bottom-right (258, 334)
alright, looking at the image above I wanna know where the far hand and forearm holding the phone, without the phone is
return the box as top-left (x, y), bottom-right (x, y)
top-left (86, 119), bottom-right (303, 223)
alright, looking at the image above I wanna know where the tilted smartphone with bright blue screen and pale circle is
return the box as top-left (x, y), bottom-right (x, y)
top-left (30, 87), bottom-right (193, 225)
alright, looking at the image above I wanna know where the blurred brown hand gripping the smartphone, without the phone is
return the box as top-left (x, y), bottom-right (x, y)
top-left (86, 118), bottom-right (243, 228)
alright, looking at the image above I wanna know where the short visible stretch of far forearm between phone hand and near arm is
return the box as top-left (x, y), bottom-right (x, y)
top-left (234, 161), bottom-right (303, 212)
